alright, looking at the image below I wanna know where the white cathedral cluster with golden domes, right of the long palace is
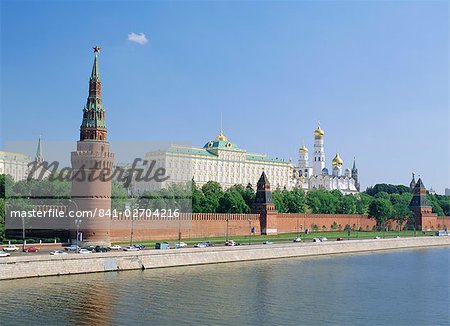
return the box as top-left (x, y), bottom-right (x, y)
top-left (293, 126), bottom-right (360, 194)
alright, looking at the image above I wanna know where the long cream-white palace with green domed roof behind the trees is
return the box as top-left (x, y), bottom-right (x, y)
top-left (134, 131), bottom-right (294, 192)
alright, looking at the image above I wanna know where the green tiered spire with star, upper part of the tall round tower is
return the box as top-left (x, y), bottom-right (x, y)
top-left (80, 46), bottom-right (106, 141)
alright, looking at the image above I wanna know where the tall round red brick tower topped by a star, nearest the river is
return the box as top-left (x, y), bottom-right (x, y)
top-left (71, 46), bottom-right (114, 244)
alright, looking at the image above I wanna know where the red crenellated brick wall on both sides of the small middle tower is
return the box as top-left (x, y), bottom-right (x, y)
top-left (111, 213), bottom-right (376, 242)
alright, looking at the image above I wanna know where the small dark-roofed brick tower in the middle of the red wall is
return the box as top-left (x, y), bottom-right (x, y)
top-left (253, 171), bottom-right (278, 235)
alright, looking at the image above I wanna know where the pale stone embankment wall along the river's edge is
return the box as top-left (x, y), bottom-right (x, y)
top-left (0, 236), bottom-right (450, 280)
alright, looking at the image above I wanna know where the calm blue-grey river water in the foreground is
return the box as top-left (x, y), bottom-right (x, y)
top-left (0, 247), bottom-right (450, 325)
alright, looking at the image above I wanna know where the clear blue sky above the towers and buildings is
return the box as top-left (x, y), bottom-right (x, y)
top-left (0, 1), bottom-right (450, 192)
